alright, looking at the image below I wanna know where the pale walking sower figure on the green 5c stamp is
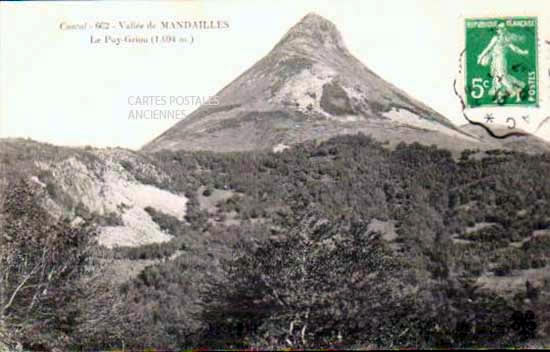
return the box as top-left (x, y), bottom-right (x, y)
top-left (477, 23), bottom-right (529, 102)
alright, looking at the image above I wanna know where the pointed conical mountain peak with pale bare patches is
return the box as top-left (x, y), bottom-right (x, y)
top-left (143, 14), bottom-right (478, 152)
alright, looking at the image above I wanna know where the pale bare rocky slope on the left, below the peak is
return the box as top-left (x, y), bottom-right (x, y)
top-left (0, 139), bottom-right (187, 248)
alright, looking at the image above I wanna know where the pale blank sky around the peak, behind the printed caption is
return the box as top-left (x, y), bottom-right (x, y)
top-left (0, 0), bottom-right (550, 149)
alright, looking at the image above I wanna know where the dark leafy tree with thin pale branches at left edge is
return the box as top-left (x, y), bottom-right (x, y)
top-left (0, 179), bottom-right (128, 350)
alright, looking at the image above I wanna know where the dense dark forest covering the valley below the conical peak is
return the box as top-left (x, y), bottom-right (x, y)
top-left (1, 135), bottom-right (550, 349)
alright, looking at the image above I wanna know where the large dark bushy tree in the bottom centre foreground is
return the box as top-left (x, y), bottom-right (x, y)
top-left (203, 214), bottom-right (407, 348)
